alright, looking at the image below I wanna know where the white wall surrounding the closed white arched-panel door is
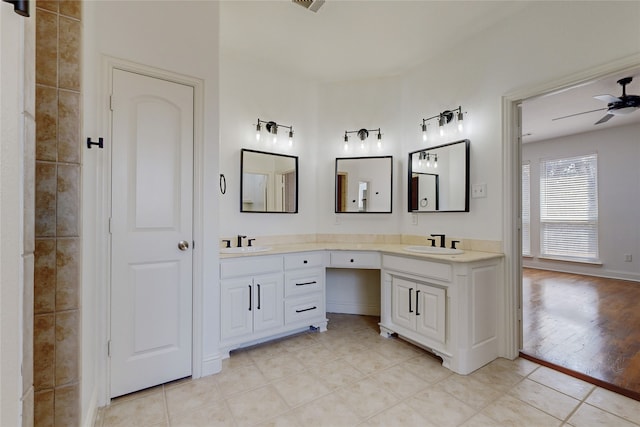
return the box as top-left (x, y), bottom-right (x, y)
top-left (82, 1), bottom-right (220, 418)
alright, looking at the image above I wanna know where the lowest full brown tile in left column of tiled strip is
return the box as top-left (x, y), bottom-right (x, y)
top-left (33, 314), bottom-right (56, 391)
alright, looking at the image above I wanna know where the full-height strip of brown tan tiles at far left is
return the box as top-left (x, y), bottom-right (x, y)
top-left (33, 0), bottom-right (81, 426)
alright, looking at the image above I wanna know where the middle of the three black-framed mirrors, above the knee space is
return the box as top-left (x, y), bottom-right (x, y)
top-left (335, 156), bottom-right (393, 213)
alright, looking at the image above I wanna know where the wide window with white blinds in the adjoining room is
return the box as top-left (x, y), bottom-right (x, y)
top-left (540, 154), bottom-right (599, 262)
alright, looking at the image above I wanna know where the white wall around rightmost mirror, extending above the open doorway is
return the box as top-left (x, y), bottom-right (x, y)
top-left (401, 2), bottom-right (640, 244)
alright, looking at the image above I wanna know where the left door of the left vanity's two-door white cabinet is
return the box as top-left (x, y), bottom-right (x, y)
top-left (220, 278), bottom-right (253, 340)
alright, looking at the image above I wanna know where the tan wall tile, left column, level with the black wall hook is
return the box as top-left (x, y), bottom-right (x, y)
top-left (36, 85), bottom-right (58, 162)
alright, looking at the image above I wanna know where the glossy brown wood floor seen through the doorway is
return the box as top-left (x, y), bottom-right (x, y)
top-left (522, 268), bottom-right (640, 400)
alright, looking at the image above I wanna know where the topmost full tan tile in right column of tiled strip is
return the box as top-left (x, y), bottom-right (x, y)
top-left (58, 17), bottom-right (80, 90)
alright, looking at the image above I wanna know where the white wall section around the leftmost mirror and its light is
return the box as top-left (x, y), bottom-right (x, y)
top-left (216, 56), bottom-right (322, 239)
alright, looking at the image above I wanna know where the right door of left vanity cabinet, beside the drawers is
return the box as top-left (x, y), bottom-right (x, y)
top-left (252, 274), bottom-right (284, 332)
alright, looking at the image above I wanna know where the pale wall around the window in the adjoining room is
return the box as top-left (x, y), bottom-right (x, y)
top-left (522, 123), bottom-right (640, 281)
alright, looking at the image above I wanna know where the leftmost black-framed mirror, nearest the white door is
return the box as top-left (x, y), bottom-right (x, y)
top-left (240, 148), bottom-right (298, 213)
